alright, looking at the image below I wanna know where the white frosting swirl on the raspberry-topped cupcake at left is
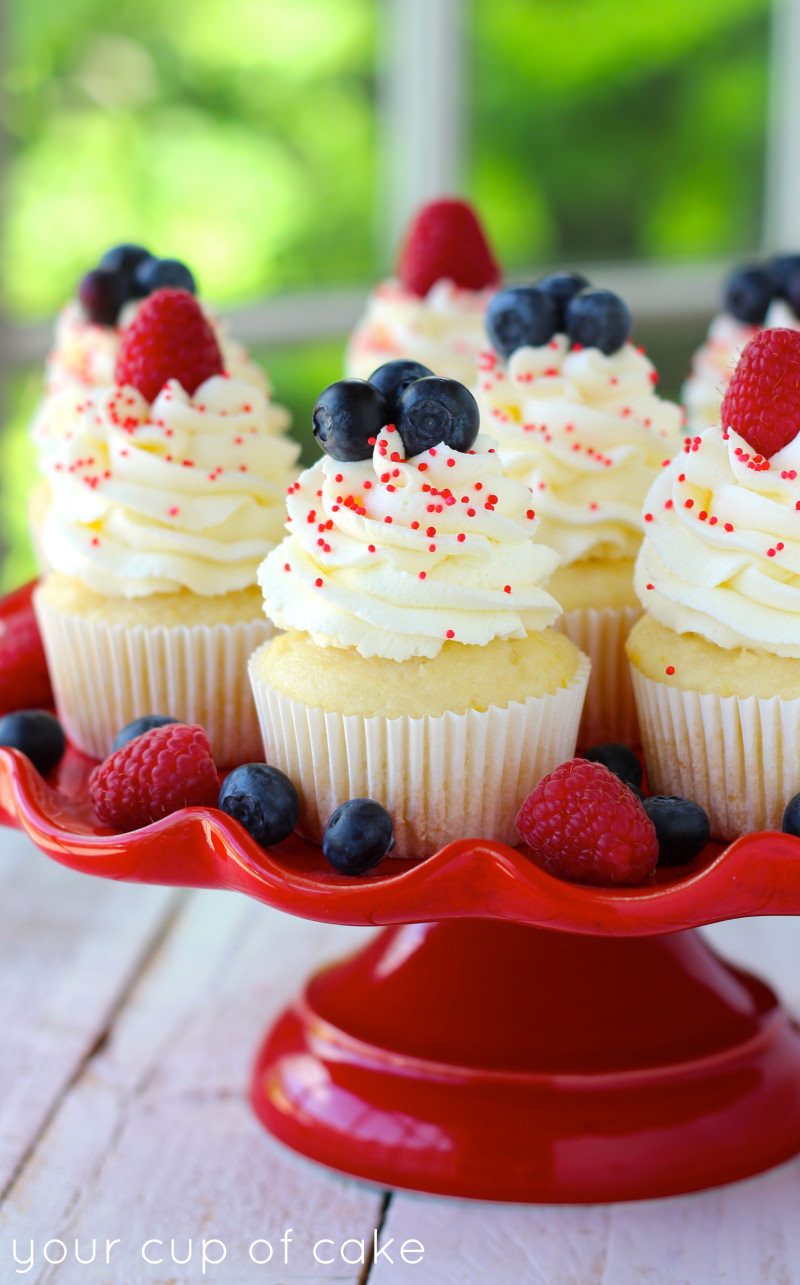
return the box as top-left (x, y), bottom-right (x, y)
top-left (44, 375), bottom-right (299, 598)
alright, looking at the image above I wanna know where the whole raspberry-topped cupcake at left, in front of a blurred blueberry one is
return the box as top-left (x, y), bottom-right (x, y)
top-left (35, 289), bottom-right (298, 765)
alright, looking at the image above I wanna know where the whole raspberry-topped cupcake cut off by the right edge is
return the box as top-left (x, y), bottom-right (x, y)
top-left (628, 329), bottom-right (800, 839)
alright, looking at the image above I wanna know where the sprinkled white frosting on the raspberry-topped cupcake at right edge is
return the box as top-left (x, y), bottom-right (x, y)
top-left (634, 425), bottom-right (800, 658)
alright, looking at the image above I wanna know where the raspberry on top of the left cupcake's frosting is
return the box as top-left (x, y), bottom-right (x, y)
top-left (114, 289), bottom-right (225, 401)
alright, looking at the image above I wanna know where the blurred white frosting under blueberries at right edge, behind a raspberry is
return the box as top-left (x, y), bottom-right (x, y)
top-left (681, 299), bottom-right (800, 433)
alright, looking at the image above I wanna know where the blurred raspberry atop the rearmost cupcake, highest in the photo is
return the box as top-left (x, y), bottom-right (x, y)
top-left (397, 199), bottom-right (500, 298)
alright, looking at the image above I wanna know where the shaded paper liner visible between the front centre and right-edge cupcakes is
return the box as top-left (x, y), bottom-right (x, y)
top-left (553, 607), bottom-right (642, 748)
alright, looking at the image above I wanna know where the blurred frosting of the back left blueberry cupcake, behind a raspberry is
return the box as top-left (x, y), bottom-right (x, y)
top-left (31, 299), bottom-right (270, 469)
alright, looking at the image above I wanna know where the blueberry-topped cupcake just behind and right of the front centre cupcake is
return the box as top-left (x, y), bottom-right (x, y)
top-left (478, 272), bottom-right (681, 745)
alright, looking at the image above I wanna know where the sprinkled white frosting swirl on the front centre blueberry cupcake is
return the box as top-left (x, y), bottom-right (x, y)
top-left (258, 427), bottom-right (560, 660)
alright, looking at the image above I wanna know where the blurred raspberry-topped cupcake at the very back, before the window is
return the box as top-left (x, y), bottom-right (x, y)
top-left (345, 200), bottom-right (500, 386)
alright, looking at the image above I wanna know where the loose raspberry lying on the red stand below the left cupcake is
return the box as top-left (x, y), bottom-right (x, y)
top-left (89, 723), bottom-right (220, 830)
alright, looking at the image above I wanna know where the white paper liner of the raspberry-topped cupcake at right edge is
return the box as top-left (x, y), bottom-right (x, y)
top-left (632, 666), bottom-right (800, 839)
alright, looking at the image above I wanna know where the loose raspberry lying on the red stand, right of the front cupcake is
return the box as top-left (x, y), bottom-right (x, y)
top-left (516, 758), bottom-right (659, 884)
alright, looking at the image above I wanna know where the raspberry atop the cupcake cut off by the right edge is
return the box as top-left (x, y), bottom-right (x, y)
top-left (722, 328), bottom-right (800, 459)
